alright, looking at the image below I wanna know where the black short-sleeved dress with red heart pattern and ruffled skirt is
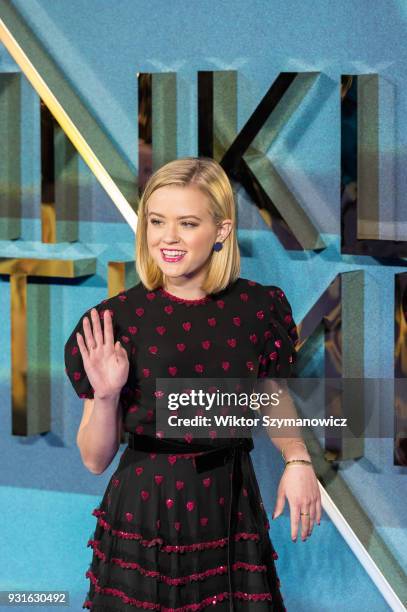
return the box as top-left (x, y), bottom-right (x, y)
top-left (65, 278), bottom-right (298, 612)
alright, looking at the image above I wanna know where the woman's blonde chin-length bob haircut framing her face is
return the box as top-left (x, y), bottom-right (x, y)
top-left (136, 157), bottom-right (240, 294)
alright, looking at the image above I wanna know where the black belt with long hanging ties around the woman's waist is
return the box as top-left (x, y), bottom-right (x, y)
top-left (128, 433), bottom-right (271, 611)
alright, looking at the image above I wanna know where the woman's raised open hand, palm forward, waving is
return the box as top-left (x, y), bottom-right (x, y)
top-left (76, 308), bottom-right (130, 399)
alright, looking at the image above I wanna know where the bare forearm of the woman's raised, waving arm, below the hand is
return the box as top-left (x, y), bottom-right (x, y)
top-left (77, 395), bottom-right (120, 474)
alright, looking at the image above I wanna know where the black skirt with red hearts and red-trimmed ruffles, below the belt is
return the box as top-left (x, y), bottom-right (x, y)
top-left (83, 447), bottom-right (285, 612)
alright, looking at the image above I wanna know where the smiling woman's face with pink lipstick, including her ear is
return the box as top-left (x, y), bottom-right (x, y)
top-left (147, 186), bottom-right (232, 280)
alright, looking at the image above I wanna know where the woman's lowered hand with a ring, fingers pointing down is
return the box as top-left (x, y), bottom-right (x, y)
top-left (273, 464), bottom-right (321, 542)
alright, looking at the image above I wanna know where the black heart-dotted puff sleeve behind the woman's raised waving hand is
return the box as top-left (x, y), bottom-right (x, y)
top-left (64, 298), bottom-right (123, 399)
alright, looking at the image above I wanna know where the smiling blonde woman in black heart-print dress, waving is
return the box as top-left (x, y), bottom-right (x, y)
top-left (65, 157), bottom-right (321, 612)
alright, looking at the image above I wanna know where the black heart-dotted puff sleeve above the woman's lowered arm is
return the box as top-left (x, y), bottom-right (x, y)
top-left (259, 285), bottom-right (299, 378)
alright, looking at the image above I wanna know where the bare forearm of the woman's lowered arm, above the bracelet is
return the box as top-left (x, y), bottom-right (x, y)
top-left (261, 381), bottom-right (310, 461)
